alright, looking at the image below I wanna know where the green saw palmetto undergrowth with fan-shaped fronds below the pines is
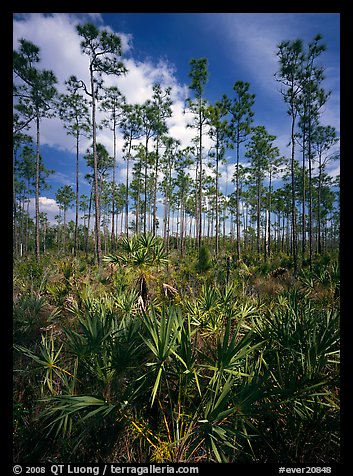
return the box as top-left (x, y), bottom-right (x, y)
top-left (13, 234), bottom-right (340, 464)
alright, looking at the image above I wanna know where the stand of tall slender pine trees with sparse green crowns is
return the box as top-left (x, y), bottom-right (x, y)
top-left (13, 23), bottom-right (339, 274)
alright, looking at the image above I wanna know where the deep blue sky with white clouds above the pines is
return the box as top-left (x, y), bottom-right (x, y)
top-left (13, 13), bottom-right (340, 227)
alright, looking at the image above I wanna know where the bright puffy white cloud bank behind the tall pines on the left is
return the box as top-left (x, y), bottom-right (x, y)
top-left (13, 13), bottom-right (195, 160)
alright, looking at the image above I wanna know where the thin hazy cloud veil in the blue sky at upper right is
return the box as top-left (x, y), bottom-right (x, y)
top-left (204, 13), bottom-right (340, 147)
